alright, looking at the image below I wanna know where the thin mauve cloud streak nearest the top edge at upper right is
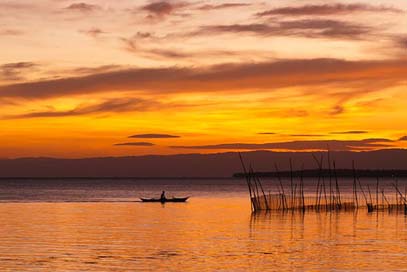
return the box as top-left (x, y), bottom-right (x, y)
top-left (257, 4), bottom-right (402, 16)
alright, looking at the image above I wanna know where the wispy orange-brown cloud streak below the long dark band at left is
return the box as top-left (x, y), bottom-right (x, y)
top-left (3, 98), bottom-right (158, 119)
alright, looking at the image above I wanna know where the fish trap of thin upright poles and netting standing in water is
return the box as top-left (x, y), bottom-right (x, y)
top-left (239, 153), bottom-right (407, 215)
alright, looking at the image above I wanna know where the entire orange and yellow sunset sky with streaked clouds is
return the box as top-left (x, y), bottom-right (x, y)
top-left (0, 0), bottom-right (407, 158)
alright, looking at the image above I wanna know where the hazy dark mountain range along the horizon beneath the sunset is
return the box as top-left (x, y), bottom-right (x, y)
top-left (0, 149), bottom-right (407, 178)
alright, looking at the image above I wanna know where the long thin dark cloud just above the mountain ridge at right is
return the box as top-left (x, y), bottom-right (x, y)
top-left (171, 139), bottom-right (394, 151)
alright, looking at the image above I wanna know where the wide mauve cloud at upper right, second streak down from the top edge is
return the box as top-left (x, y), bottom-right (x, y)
top-left (199, 19), bottom-right (373, 39)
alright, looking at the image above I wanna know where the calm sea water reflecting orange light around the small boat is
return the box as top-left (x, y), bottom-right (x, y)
top-left (0, 180), bottom-right (407, 271)
